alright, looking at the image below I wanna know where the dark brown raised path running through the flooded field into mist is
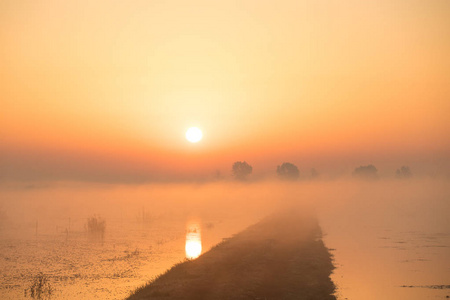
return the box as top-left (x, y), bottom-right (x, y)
top-left (128, 210), bottom-right (336, 300)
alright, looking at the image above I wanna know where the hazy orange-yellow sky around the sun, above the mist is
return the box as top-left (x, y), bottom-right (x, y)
top-left (0, 0), bottom-right (450, 181)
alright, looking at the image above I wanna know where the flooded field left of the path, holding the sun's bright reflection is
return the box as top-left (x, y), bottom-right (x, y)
top-left (0, 182), bottom-right (278, 299)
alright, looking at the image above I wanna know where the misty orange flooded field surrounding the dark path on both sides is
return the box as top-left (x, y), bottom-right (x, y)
top-left (0, 178), bottom-right (450, 299)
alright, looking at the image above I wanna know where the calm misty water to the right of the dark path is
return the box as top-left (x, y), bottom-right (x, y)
top-left (320, 181), bottom-right (450, 300)
